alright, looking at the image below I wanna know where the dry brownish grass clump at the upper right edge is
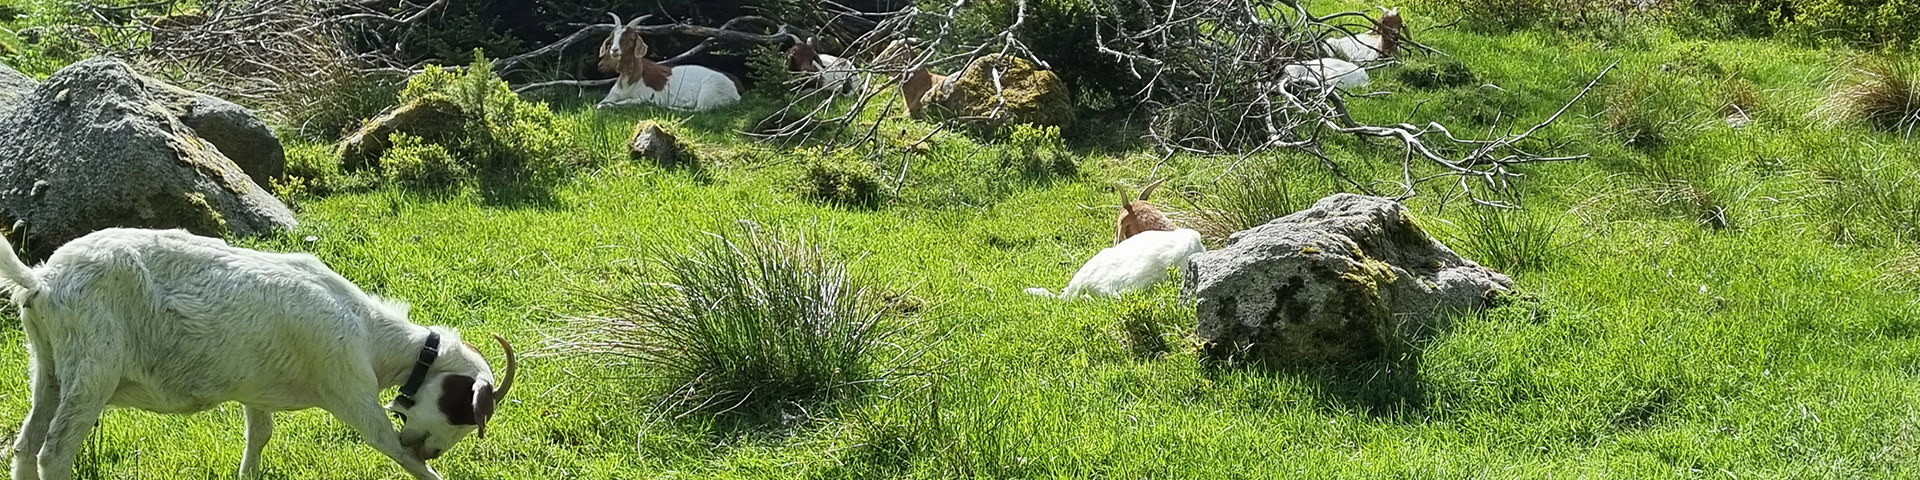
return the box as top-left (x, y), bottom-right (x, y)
top-left (1814, 58), bottom-right (1920, 136)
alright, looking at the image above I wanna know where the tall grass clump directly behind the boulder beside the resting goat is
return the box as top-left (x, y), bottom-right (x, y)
top-left (1188, 161), bottom-right (1306, 242)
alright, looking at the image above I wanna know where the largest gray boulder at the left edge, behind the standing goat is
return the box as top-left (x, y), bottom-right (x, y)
top-left (0, 58), bottom-right (296, 259)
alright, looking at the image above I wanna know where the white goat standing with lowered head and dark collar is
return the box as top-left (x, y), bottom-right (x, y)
top-left (0, 228), bottom-right (515, 480)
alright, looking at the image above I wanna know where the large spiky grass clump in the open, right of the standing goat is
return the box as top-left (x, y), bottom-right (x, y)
top-left (557, 227), bottom-right (902, 415)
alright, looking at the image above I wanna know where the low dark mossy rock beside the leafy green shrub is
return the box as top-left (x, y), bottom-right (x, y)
top-left (338, 94), bottom-right (467, 171)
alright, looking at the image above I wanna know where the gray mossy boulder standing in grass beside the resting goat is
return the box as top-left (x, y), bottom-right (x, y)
top-left (1185, 194), bottom-right (1513, 365)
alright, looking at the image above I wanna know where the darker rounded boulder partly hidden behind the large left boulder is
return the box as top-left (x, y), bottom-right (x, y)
top-left (140, 77), bottom-right (286, 186)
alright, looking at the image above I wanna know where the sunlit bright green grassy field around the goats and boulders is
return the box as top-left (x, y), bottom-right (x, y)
top-left (0, 1), bottom-right (1920, 478)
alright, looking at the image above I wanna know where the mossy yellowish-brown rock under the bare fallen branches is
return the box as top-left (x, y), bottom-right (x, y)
top-left (922, 54), bottom-right (1073, 131)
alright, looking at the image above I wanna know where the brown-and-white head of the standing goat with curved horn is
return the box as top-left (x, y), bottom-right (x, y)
top-left (386, 334), bottom-right (518, 461)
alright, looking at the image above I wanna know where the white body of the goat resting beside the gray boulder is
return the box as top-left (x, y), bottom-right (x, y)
top-left (1027, 228), bottom-right (1206, 300)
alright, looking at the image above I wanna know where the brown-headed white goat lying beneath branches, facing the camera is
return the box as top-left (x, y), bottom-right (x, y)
top-left (599, 13), bottom-right (743, 111)
